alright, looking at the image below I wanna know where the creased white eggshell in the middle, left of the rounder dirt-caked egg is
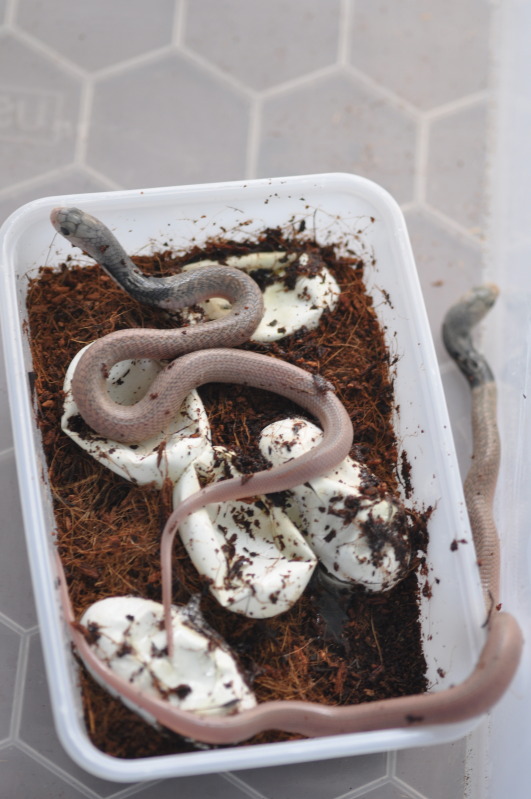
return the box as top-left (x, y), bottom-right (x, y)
top-left (173, 447), bottom-right (317, 618)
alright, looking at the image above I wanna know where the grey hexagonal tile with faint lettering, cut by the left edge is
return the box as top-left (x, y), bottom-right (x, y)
top-left (0, 34), bottom-right (81, 187)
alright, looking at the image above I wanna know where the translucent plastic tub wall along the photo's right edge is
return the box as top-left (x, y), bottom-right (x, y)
top-left (480, 0), bottom-right (531, 797)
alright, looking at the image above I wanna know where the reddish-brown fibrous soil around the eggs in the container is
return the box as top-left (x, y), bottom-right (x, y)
top-left (27, 231), bottom-right (429, 758)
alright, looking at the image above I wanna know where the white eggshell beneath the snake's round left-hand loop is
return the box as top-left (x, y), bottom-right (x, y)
top-left (61, 344), bottom-right (210, 488)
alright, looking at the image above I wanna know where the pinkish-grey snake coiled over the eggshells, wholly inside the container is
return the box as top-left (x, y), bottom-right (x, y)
top-left (51, 208), bottom-right (353, 654)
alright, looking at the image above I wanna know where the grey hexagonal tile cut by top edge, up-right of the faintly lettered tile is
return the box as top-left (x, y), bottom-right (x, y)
top-left (16, 0), bottom-right (175, 70)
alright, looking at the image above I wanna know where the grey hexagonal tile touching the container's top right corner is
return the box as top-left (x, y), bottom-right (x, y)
top-left (258, 71), bottom-right (416, 202)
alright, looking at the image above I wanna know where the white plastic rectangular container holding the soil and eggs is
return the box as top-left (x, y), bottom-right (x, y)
top-left (0, 174), bottom-right (485, 782)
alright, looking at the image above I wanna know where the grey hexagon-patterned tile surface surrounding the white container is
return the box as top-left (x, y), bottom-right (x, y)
top-left (0, 0), bottom-right (498, 799)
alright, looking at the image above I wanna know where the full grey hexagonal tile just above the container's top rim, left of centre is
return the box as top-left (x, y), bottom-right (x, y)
top-left (87, 55), bottom-right (249, 188)
